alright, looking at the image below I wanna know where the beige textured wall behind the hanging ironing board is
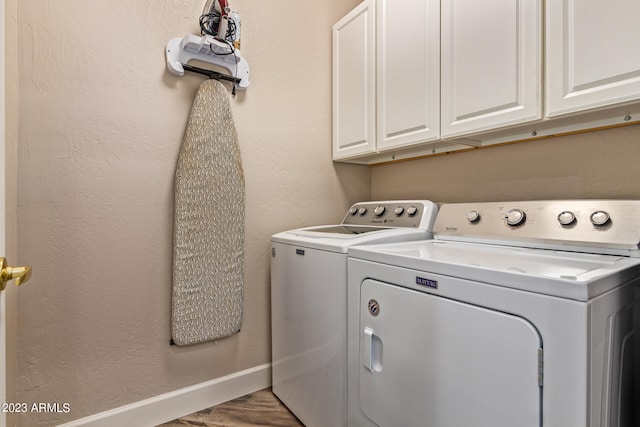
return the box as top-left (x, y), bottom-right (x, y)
top-left (12, 0), bottom-right (370, 425)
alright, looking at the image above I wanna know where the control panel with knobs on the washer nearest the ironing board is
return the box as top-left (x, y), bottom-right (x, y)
top-left (342, 200), bottom-right (438, 228)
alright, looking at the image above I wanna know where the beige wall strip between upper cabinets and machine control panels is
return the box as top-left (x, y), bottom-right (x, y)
top-left (371, 125), bottom-right (640, 202)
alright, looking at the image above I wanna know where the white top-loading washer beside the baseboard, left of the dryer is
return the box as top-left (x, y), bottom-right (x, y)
top-left (271, 200), bottom-right (437, 427)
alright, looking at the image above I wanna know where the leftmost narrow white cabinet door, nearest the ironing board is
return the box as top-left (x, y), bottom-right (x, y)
top-left (333, 0), bottom-right (376, 160)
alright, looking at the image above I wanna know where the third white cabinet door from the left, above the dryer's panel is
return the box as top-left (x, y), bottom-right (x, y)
top-left (441, 0), bottom-right (540, 138)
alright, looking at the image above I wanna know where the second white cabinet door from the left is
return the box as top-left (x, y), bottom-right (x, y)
top-left (376, 0), bottom-right (440, 150)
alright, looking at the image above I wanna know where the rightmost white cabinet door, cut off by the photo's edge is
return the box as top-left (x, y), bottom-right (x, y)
top-left (546, 0), bottom-right (640, 117)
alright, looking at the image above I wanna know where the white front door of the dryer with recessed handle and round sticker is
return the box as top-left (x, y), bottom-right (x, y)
top-left (359, 280), bottom-right (542, 427)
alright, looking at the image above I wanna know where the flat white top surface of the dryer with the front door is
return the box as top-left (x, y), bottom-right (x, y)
top-left (349, 240), bottom-right (640, 301)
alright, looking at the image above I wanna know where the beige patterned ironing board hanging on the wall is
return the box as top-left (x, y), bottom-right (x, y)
top-left (172, 80), bottom-right (245, 345)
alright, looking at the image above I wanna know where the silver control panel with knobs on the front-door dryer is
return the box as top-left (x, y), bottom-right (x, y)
top-left (433, 200), bottom-right (640, 253)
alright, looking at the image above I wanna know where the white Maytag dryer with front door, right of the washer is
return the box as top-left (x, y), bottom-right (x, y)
top-left (348, 200), bottom-right (640, 427)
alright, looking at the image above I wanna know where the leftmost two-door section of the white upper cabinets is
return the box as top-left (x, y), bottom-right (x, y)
top-left (333, 0), bottom-right (440, 160)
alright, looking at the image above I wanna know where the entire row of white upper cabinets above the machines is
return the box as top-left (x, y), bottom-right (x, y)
top-left (333, 0), bottom-right (640, 163)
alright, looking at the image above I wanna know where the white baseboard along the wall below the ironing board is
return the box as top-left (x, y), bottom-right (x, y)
top-left (59, 363), bottom-right (271, 427)
